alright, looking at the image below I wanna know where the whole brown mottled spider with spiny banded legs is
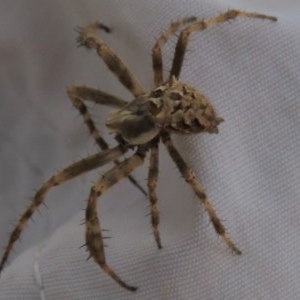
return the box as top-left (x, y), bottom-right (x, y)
top-left (0, 10), bottom-right (276, 291)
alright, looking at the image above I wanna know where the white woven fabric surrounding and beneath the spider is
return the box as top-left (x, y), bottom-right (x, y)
top-left (0, 0), bottom-right (300, 300)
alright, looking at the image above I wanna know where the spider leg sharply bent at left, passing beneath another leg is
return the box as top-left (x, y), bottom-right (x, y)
top-left (67, 86), bottom-right (147, 195)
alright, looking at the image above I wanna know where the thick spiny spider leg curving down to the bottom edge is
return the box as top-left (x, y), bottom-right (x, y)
top-left (85, 147), bottom-right (146, 291)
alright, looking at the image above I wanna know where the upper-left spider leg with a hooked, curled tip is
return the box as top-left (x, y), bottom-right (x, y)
top-left (77, 22), bottom-right (145, 97)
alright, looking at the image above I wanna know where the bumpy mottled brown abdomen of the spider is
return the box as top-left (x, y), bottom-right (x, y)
top-left (149, 77), bottom-right (224, 134)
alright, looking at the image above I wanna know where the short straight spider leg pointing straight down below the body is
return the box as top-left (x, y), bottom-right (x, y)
top-left (148, 139), bottom-right (162, 249)
